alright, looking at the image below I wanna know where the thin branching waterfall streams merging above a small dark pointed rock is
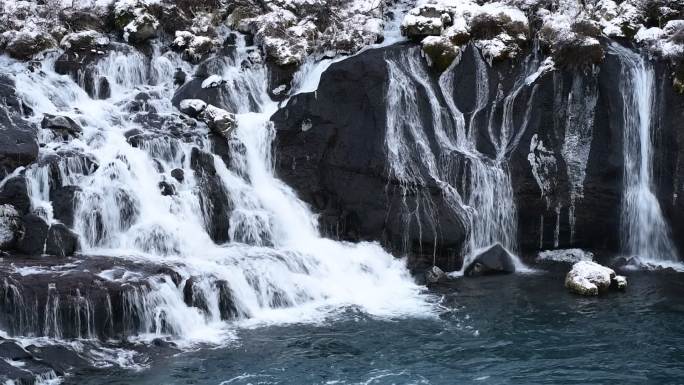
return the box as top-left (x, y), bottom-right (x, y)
top-left (385, 45), bottom-right (539, 271)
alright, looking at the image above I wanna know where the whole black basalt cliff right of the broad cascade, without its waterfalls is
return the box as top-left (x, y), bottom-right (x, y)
top-left (272, 41), bottom-right (684, 270)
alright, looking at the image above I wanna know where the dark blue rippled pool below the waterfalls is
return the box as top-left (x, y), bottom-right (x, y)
top-left (73, 271), bottom-right (684, 384)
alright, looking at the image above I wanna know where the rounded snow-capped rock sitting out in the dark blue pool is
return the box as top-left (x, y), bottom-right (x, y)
top-left (565, 261), bottom-right (627, 295)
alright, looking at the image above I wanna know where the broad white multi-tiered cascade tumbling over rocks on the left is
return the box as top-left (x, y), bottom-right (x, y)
top-left (0, 31), bottom-right (433, 344)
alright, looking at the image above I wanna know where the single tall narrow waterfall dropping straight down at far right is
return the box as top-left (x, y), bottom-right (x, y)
top-left (610, 43), bottom-right (677, 262)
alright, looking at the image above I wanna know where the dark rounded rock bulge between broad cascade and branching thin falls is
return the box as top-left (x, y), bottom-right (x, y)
top-left (272, 46), bottom-right (466, 270)
